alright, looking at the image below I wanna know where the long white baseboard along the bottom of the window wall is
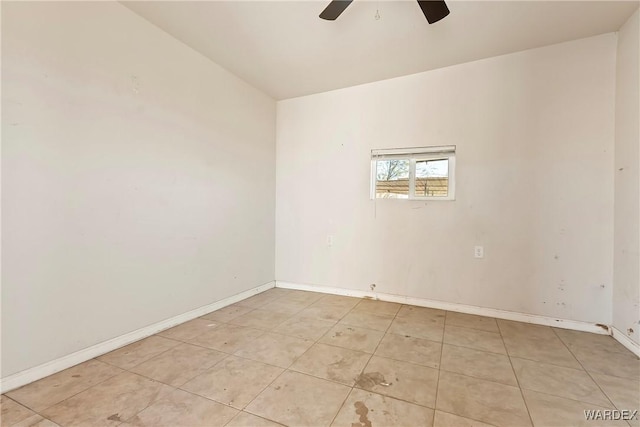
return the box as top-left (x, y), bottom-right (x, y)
top-left (276, 280), bottom-right (612, 338)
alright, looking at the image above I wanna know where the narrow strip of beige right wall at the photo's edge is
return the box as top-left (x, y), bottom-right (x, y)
top-left (613, 11), bottom-right (640, 343)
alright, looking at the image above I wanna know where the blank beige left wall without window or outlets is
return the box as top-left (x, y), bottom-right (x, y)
top-left (2, 2), bottom-right (276, 377)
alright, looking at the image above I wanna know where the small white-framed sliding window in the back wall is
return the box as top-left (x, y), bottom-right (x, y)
top-left (371, 146), bottom-right (456, 200)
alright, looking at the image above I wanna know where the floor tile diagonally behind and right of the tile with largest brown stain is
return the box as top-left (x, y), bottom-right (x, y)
top-left (440, 344), bottom-right (518, 387)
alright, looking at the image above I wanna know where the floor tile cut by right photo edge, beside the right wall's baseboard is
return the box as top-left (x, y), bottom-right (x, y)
top-left (572, 347), bottom-right (640, 378)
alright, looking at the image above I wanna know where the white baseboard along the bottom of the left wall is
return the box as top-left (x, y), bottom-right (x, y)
top-left (0, 282), bottom-right (275, 393)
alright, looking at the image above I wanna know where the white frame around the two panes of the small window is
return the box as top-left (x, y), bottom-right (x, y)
top-left (370, 145), bottom-right (456, 201)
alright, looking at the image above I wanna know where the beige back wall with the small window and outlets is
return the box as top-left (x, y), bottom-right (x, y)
top-left (276, 34), bottom-right (616, 324)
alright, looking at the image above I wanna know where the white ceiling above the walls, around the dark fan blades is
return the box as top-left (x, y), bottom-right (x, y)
top-left (123, 0), bottom-right (639, 99)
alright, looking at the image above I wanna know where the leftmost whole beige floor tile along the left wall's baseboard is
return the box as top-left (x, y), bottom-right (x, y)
top-left (7, 360), bottom-right (122, 412)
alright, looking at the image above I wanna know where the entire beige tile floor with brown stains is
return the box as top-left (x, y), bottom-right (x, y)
top-left (1, 288), bottom-right (640, 427)
